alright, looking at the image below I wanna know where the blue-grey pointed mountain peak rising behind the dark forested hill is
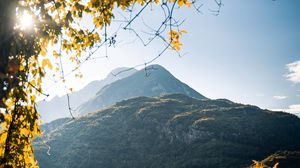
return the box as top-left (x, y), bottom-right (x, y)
top-left (78, 65), bottom-right (206, 115)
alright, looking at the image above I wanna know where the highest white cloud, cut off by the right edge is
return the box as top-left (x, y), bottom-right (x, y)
top-left (286, 60), bottom-right (300, 83)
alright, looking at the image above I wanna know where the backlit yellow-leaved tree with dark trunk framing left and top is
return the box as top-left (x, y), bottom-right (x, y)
top-left (0, 0), bottom-right (203, 167)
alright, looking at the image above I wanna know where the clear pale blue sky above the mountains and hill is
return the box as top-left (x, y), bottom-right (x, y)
top-left (45, 0), bottom-right (300, 112)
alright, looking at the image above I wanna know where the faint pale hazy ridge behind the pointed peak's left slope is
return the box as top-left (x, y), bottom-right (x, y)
top-left (37, 67), bottom-right (137, 123)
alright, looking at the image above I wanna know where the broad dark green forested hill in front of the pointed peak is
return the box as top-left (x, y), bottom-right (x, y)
top-left (34, 94), bottom-right (300, 168)
